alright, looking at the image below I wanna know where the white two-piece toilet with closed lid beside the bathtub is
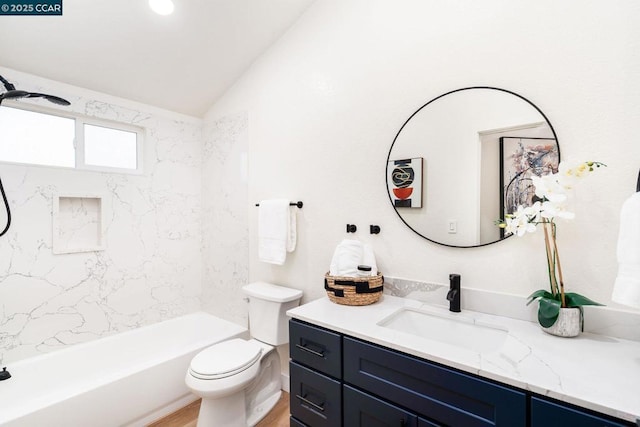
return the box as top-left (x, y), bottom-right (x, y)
top-left (185, 282), bottom-right (302, 427)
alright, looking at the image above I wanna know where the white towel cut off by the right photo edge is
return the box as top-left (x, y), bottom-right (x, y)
top-left (611, 193), bottom-right (640, 308)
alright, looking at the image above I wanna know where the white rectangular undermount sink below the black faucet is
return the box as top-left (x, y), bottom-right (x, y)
top-left (377, 307), bottom-right (508, 353)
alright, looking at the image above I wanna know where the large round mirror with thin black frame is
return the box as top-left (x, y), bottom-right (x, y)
top-left (387, 87), bottom-right (560, 247)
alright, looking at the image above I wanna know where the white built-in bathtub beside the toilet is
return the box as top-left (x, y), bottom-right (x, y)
top-left (0, 312), bottom-right (247, 427)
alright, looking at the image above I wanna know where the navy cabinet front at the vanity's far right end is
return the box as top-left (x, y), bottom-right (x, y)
top-left (531, 397), bottom-right (633, 427)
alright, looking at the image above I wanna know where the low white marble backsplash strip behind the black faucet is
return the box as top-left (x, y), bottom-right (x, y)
top-left (384, 277), bottom-right (640, 341)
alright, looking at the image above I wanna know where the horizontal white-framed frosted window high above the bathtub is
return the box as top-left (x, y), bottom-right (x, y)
top-left (0, 105), bottom-right (142, 173)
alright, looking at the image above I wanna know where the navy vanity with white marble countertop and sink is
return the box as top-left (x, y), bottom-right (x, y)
top-left (288, 294), bottom-right (640, 427)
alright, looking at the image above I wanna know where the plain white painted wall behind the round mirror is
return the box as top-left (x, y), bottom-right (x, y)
top-left (210, 0), bottom-right (640, 304)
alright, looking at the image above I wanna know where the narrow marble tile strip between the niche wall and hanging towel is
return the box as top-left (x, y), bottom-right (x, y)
top-left (202, 112), bottom-right (251, 326)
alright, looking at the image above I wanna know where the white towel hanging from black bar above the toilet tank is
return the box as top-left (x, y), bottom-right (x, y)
top-left (258, 199), bottom-right (296, 265)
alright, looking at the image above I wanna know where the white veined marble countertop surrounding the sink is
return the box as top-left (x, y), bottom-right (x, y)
top-left (287, 295), bottom-right (640, 422)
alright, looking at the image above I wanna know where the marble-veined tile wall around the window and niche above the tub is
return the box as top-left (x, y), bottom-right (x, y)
top-left (0, 68), bottom-right (203, 363)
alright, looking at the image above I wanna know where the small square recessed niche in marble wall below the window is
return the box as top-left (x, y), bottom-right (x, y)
top-left (53, 194), bottom-right (104, 254)
